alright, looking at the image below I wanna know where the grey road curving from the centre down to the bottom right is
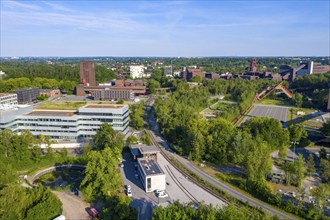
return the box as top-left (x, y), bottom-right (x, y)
top-left (147, 96), bottom-right (295, 219)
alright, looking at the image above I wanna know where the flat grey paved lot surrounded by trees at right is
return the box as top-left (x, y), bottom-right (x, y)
top-left (242, 105), bottom-right (289, 123)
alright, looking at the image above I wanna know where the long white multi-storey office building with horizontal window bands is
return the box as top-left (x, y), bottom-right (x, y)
top-left (0, 104), bottom-right (128, 141)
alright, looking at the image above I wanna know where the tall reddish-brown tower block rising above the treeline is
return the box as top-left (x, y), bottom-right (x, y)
top-left (80, 61), bottom-right (96, 86)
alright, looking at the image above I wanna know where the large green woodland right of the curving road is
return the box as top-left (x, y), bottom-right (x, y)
top-left (154, 80), bottom-right (328, 219)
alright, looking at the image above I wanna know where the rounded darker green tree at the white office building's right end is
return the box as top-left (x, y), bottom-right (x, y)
top-left (94, 123), bottom-right (124, 158)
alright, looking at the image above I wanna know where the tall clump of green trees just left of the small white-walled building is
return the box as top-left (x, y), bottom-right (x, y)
top-left (80, 123), bottom-right (137, 220)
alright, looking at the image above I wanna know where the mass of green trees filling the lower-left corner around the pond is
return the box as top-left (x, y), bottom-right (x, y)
top-left (0, 130), bottom-right (84, 220)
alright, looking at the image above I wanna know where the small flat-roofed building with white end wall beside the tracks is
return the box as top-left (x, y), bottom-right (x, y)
top-left (130, 144), bottom-right (166, 192)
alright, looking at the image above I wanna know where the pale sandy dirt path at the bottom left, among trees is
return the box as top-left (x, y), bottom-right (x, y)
top-left (53, 191), bottom-right (89, 220)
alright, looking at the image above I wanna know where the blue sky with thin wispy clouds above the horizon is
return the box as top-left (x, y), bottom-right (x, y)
top-left (0, 0), bottom-right (330, 57)
